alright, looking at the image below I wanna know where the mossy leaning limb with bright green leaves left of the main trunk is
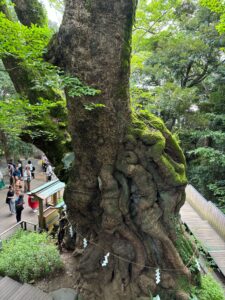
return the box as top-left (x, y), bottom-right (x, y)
top-left (0, 0), bottom-right (71, 169)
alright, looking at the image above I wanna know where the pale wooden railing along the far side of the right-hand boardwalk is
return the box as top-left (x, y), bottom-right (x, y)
top-left (186, 184), bottom-right (225, 240)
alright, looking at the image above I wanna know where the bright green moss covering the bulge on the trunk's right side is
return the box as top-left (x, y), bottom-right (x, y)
top-left (128, 111), bottom-right (187, 186)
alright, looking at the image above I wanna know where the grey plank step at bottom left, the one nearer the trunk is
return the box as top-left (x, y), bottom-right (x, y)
top-left (7, 283), bottom-right (53, 300)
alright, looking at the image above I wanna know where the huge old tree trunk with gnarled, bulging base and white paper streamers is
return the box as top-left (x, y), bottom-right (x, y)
top-left (1, 0), bottom-right (199, 300)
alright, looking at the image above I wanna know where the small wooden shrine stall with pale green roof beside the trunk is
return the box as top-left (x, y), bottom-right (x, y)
top-left (27, 179), bottom-right (65, 230)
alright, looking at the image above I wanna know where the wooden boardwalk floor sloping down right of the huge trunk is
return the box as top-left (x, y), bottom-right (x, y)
top-left (180, 201), bottom-right (225, 276)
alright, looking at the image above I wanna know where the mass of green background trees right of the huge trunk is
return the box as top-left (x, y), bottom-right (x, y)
top-left (132, 1), bottom-right (225, 208)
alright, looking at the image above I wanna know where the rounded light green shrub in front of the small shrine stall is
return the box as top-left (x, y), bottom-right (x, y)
top-left (0, 230), bottom-right (62, 282)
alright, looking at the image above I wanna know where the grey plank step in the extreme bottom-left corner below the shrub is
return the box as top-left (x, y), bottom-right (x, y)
top-left (0, 276), bottom-right (22, 300)
